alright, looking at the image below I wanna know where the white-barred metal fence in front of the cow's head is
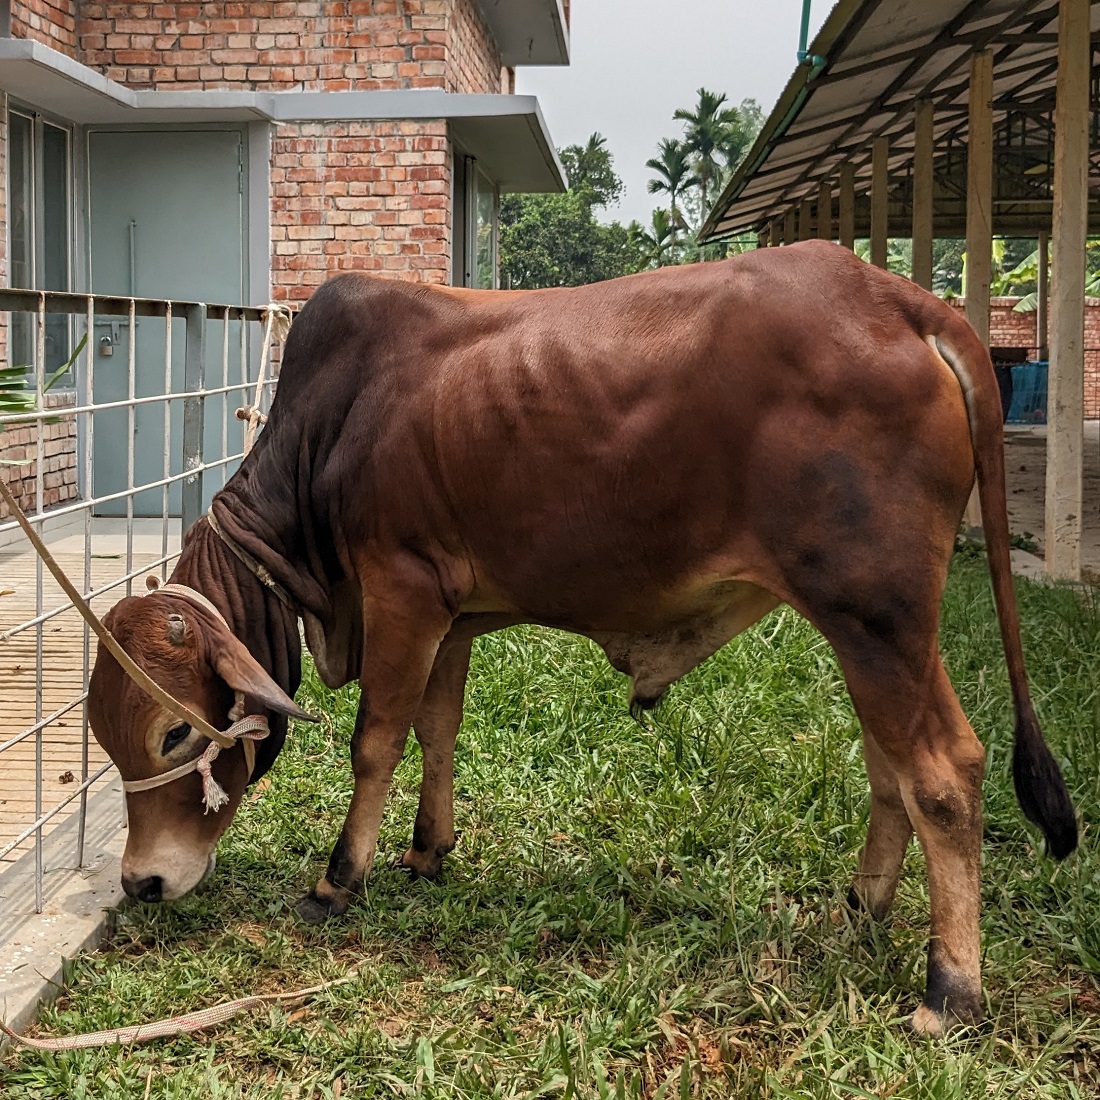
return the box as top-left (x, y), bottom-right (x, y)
top-left (0, 290), bottom-right (275, 924)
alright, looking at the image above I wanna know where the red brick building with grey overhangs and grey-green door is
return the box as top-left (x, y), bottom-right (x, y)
top-left (0, 0), bottom-right (569, 504)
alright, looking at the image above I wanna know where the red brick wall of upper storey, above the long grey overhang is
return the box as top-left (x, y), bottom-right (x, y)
top-left (81, 0), bottom-right (501, 91)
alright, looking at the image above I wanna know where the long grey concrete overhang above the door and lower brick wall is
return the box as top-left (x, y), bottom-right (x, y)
top-left (0, 36), bottom-right (565, 191)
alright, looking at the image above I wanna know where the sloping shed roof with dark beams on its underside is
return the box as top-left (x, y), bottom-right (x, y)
top-left (700, 0), bottom-right (1100, 240)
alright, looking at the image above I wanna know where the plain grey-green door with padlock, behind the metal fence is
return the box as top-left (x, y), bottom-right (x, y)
top-left (88, 129), bottom-right (246, 516)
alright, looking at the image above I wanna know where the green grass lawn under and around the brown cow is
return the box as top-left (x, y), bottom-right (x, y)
top-left (0, 561), bottom-right (1100, 1100)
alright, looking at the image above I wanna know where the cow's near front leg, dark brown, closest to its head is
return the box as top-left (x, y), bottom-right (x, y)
top-left (298, 576), bottom-right (451, 924)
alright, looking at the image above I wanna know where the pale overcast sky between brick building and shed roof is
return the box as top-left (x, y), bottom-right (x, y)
top-left (516, 0), bottom-right (832, 222)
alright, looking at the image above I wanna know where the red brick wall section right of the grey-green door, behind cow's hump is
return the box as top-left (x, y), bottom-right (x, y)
top-left (272, 122), bottom-right (451, 303)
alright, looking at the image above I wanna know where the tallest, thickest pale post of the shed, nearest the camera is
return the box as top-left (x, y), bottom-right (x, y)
top-left (1045, 0), bottom-right (1092, 581)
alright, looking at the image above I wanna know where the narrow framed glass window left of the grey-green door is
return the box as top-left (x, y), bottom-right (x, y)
top-left (8, 111), bottom-right (73, 385)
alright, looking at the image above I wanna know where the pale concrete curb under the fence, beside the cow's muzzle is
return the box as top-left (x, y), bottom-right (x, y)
top-left (0, 776), bottom-right (125, 1049)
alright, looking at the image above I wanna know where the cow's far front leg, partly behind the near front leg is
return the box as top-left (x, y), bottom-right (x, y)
top-left (402, 641), bottom-right (471, 879)
